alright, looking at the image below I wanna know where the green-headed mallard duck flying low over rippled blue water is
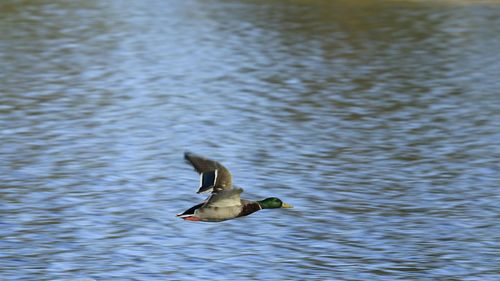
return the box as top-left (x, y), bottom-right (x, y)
top-left (177, 152), bottom-right (293, 222)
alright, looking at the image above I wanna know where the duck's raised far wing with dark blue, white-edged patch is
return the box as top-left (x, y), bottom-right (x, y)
top-left (184, 152), bottom-right (233, 193)
